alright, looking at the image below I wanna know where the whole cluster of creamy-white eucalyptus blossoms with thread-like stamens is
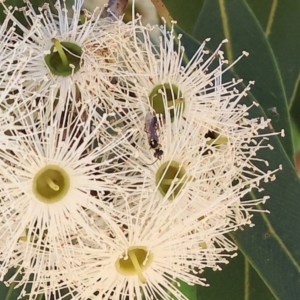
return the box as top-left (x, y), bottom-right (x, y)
top-left (0, 0), bottom-right (280, 300)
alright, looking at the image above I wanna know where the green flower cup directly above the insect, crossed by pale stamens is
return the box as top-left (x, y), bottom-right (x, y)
top-left (149, 83), bottom-right (185, 121)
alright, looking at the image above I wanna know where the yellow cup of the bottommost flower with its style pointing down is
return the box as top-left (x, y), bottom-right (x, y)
top-left (115, 247), bottom-right (153, 283)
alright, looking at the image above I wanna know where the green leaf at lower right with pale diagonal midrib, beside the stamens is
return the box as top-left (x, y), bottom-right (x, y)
top-left (231, 108), bottom-right (300, 299)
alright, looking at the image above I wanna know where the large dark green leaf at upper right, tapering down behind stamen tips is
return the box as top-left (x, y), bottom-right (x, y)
top-left (194, 0), bottom-right (294, 161)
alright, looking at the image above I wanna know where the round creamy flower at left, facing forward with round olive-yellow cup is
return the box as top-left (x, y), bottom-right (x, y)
top-left (0, 95), bottom-right (135, 288)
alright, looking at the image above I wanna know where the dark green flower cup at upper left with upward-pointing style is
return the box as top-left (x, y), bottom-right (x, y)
top-left (44, 38), bottom-right (82, 77)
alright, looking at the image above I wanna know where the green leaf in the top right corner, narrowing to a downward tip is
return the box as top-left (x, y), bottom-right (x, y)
top-left (247, 0), bottom-right (300, 104)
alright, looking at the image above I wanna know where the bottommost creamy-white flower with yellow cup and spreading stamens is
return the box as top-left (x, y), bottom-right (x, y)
top-left (57, 191), bottom-right (236, 300)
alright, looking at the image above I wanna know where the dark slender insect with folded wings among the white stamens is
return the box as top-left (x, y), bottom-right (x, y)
top-left (145, 112), bottom-right (164, 159)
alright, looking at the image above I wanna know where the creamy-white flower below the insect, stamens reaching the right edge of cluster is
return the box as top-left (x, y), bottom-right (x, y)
top-left (110, 97), bottom-right (277, 227)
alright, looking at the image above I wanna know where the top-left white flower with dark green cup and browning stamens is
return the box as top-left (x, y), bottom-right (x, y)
top-left (0, 0), bottom-right (144, 115)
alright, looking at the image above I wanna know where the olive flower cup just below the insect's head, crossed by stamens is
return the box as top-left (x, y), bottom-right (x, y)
top-left (155, 160), bottom-right (190, 200)
